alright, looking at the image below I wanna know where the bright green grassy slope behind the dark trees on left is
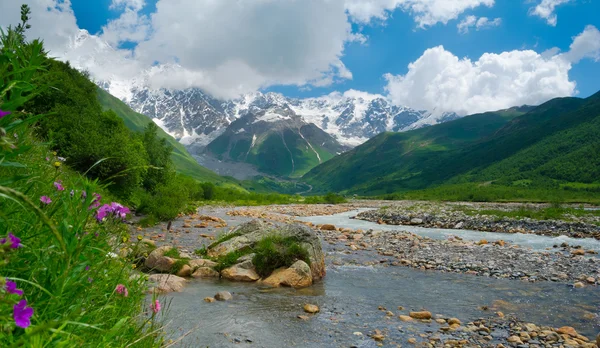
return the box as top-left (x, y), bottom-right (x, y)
top-left (98, 88), bottom-right (231, 182)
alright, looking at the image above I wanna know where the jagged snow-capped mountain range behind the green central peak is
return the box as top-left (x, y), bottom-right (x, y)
top-left (100, 82), bottom-right (459, 146)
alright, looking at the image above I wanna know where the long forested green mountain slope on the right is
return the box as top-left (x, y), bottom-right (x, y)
top-left (304, 95), bottom-right (600, 194)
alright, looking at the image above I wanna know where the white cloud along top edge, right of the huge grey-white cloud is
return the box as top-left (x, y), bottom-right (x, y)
top-left (345, 0), bottom-right (494, 28)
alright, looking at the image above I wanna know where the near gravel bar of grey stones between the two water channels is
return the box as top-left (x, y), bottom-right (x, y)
top-left (320, 226), bottom-right (600, 287)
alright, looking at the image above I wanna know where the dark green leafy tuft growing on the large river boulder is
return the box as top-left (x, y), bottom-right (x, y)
top-left (252, 236), bottom-right (310, 277)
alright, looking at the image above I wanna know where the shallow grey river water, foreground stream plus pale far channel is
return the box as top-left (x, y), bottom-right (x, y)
top-left (163, 208), bottom-right (600, 347)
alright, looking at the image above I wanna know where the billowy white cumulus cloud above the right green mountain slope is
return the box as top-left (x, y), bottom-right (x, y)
top-left (385, 26), bottom-right (600, 114)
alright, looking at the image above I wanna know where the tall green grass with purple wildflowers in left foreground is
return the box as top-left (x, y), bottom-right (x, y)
top-left (0, 12), bottom-right (162, 347)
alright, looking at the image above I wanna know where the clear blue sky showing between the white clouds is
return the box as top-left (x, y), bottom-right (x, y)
top-left (65, 0), bottom-right (600, 102)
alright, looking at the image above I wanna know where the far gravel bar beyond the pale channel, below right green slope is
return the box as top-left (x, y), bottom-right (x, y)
top-left (357, 202), bottom-right (600, 239)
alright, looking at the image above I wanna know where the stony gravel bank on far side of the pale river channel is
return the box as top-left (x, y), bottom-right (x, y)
top-left (356, 205), bottom-right (600, 240)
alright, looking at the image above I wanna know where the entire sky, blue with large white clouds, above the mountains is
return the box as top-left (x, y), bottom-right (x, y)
top-left (0, 0), bottom-right (600, 114)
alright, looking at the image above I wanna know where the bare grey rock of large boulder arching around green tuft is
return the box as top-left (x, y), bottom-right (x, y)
top-left (208, 220), bottom-right (325, 282)
